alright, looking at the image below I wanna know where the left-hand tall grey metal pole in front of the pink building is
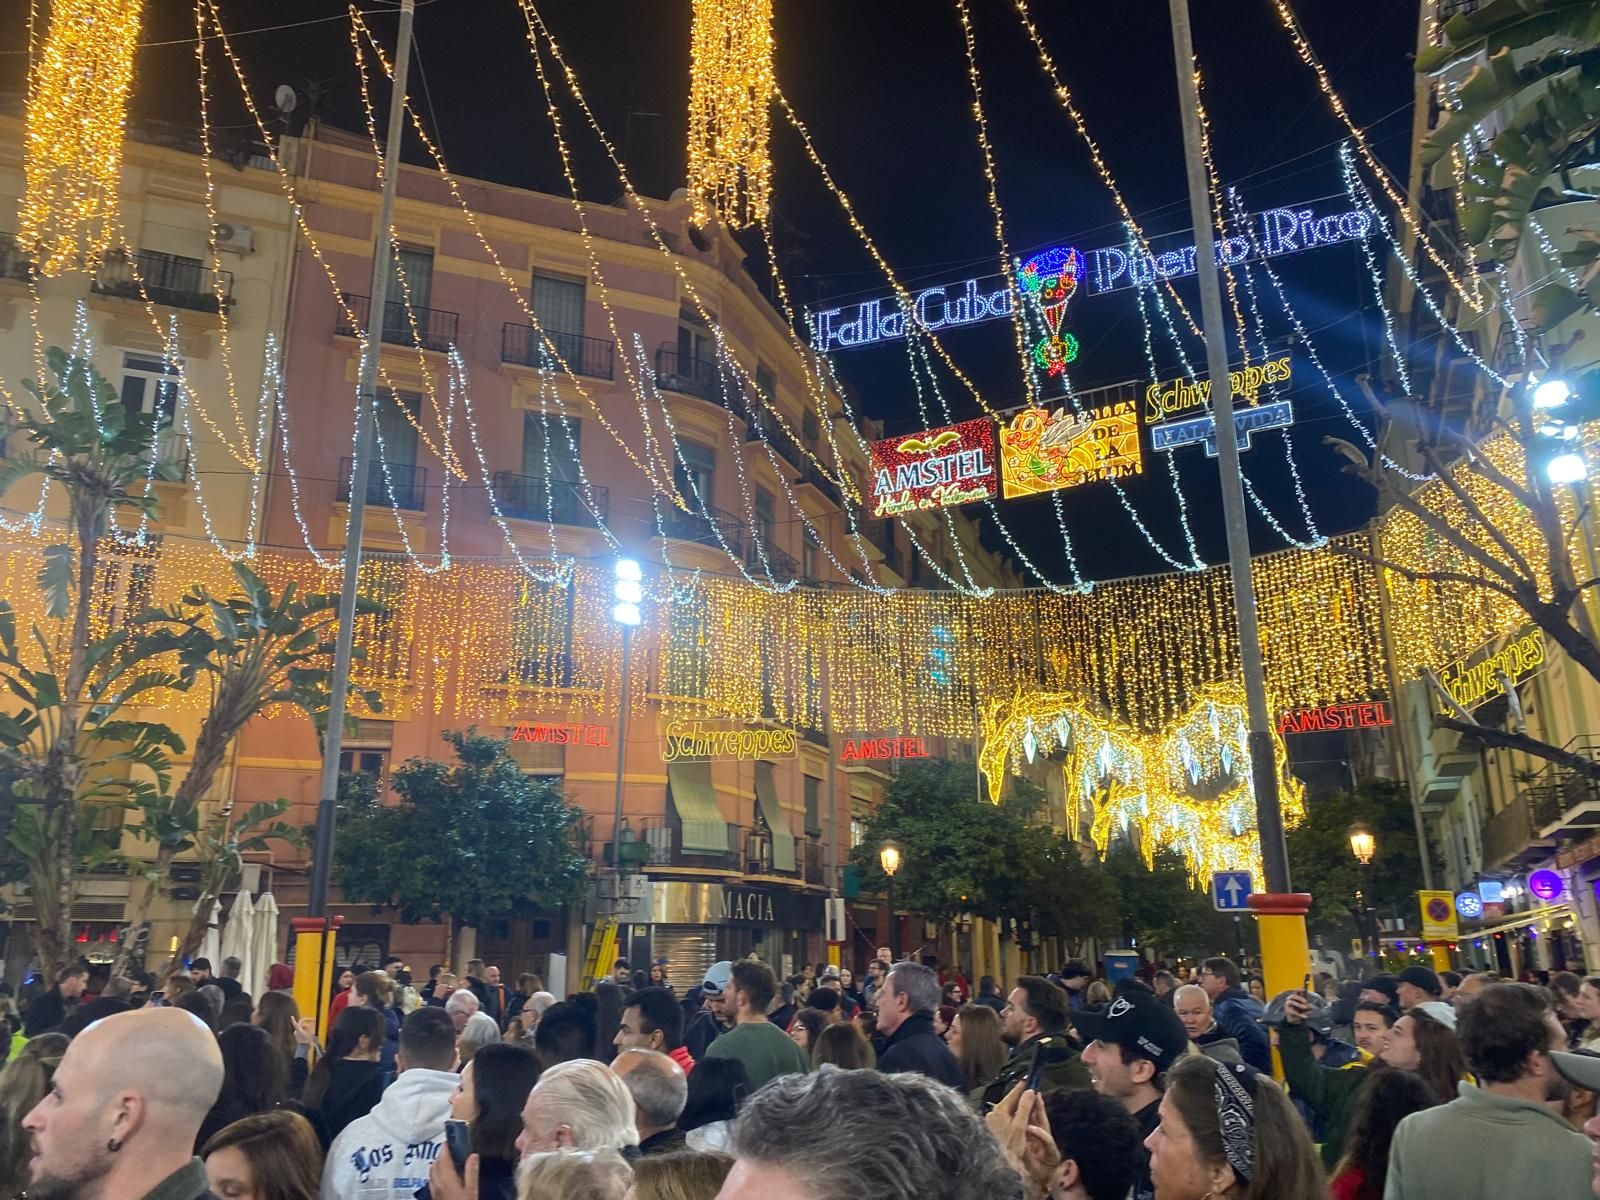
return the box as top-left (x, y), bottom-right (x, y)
top-left (307, 0), bottom-right (416, 917)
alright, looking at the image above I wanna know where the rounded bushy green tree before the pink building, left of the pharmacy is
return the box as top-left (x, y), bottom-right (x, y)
top-left (333, 730), bottom-right (589, 928)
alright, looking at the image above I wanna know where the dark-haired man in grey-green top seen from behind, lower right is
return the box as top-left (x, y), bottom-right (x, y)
top-left (1384, 984), bottom-right (1594, 1200)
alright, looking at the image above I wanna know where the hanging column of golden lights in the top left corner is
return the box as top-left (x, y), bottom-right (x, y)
top-left (18, 0), bottom-right (144, 277)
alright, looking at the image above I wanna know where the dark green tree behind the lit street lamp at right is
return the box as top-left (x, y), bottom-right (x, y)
top-left (1288, 779), bottom-right (1422, 936)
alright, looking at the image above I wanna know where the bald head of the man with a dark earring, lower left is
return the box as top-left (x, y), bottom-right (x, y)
top-left (22, 1008), bottom-right (222, 1200)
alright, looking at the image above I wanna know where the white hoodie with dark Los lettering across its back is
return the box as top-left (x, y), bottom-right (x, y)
top-left (322, 1067), bottom-right (461, 1200)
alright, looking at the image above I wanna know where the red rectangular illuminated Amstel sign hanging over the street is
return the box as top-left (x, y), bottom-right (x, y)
top-left (870, 421), bottom-right (995, 517)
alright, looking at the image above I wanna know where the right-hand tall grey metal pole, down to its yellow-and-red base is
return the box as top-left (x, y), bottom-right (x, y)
top-left (1170, 0), bottom-right (1290, 894)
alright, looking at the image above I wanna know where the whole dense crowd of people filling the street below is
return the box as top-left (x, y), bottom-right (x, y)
top-left (0, 950), bottom-right (1600, 1200)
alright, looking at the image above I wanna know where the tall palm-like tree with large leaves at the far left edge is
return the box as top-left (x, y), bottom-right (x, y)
top-left (0, 347), bottom-right (192, 976)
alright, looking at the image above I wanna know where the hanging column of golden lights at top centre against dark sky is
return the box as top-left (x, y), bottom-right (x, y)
top-left (688, 0), bottom-right (773, 229)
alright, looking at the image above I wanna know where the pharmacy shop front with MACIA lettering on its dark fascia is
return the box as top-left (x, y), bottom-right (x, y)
top-left (619, 880), bottom-right (824, 994)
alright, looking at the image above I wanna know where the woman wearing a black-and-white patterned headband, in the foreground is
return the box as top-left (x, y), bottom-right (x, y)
top-left (1144, 1056), bottom-right (1328, 1200)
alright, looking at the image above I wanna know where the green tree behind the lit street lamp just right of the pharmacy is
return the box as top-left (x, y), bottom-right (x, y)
top-left (850, 758), bottom-right (1043, 920)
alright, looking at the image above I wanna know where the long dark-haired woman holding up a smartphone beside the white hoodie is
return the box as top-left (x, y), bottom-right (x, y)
top-left (416, 1042), bottom-right (539, 1200)
